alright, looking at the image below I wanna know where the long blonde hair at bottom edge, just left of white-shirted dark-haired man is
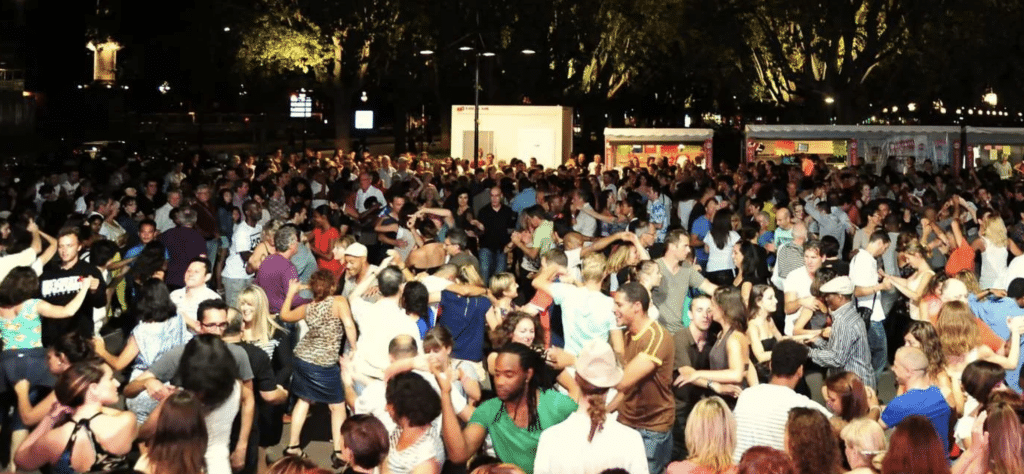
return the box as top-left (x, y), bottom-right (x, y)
top-left (685, 396), bottom-right (736, 472)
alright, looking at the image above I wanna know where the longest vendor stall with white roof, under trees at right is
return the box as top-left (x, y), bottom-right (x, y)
top-left (743, 125), bottom-right (961, 173)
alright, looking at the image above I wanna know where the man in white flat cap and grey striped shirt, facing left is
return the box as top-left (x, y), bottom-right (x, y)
top-left (808, 276), bottom-right (874, 389)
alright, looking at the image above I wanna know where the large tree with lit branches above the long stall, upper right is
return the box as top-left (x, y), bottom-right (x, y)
top-left (736, 0), bottom-right (933, 122)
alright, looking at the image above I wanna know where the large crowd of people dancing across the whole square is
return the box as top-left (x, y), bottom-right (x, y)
top-left (0, 150), bottom-right (1024, 474)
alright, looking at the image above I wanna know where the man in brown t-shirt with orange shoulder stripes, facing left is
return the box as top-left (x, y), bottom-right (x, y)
top-left (608, 283), bottom-right (676, 474)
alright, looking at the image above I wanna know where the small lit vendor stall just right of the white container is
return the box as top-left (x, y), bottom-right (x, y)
top-left (604, 128), bottom-right (715, 168)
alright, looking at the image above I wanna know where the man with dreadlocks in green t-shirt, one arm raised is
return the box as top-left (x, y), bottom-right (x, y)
top-left (433, 343), bottom-right (578, 474)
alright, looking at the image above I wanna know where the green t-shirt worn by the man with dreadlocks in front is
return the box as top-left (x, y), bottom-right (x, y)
top-left (469, 390), bottom-right (579, 474)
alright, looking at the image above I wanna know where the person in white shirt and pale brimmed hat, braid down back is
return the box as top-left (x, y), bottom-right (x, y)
top-left (534, 339), bottom-right (648, 474)
